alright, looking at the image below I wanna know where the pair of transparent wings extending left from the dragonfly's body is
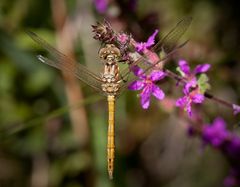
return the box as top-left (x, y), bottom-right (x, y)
top-left (27, 31), bottom-right (103, 93)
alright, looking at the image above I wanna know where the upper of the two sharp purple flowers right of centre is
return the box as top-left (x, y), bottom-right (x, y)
top-left (178, 60), bottom-right (211, 93)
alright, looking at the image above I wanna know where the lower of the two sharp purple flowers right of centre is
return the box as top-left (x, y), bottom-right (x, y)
top-left (176, 90), bottom-right (204, 116)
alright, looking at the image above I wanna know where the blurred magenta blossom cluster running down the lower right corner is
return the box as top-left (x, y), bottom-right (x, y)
top-left (190, 117), bottom-right (240, 187)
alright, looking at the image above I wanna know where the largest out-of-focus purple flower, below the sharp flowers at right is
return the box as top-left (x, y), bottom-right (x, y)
top-left (202, 118), bottom-right (230, 148)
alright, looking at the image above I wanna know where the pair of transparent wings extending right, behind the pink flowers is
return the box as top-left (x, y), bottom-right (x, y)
top-left (121, 17), bottom-right (192, 89)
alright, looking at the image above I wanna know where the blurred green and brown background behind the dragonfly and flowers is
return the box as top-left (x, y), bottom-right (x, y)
top-left (0, 0), bottom-right (240, 187)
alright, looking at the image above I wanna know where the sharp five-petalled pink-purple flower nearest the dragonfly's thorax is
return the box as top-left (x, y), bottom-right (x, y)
top-left (128, 66), bottom-right (165, 109)
